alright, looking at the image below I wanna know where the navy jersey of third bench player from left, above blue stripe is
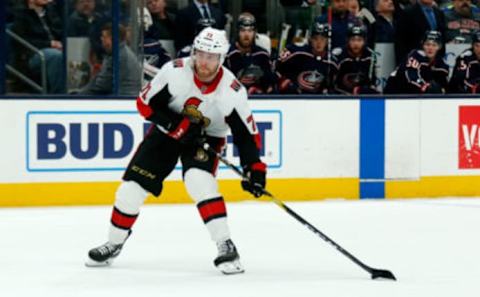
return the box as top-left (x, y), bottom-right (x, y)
top-left (335, 47), bottom-right (377, 95)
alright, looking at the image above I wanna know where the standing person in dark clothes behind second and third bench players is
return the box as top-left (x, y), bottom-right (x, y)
top-left (316, 0), bottom-right (355, 48)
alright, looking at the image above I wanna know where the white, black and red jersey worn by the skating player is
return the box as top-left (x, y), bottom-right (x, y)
top-left (137, 57), bottom-right (261, 165)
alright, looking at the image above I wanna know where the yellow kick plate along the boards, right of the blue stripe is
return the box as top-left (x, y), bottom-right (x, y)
top-left (385, 176), bottom-right (480, 198)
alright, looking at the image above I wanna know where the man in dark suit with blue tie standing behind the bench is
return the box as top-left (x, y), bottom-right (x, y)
top-left (395, 0), bottom-right (445, 64)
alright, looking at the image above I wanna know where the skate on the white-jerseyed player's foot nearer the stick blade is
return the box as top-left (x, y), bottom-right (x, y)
top-left (213, 239), bottom-right (245, 274)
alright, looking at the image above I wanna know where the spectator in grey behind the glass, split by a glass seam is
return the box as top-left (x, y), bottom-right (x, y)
top-left (79, 23), bottom-right (142, 96)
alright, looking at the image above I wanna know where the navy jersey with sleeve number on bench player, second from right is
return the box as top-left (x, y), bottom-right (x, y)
top-left (384, 50), bottom-right (448, 94)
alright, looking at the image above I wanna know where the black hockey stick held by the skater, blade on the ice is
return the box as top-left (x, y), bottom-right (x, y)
top-left (202, 143), bottom-right (397, 280)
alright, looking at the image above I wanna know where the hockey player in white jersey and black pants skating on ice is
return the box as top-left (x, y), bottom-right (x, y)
top-left (87, 28), bottom-right (266, 274)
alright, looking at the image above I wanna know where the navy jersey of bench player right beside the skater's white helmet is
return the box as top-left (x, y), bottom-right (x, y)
top-left (224, 44), bottom-right (277, 93)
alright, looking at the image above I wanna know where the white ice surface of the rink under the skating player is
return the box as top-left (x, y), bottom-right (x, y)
top-left (0, 199), bottom-right (480, 297)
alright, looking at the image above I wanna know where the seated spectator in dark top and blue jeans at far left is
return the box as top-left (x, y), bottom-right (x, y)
top-left (13, 0), bottom-right (65, 94)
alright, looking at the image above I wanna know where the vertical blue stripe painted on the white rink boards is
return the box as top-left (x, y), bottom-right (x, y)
top-left (360, 99), bottom-right (385, 198)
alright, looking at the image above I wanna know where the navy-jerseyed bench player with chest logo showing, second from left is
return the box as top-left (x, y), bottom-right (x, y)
top-left (276, 22), bottom-right (337, 94)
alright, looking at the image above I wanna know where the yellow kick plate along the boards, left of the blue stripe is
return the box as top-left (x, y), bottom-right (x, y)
top-left (0, 178), bottom-right (359, 207)
